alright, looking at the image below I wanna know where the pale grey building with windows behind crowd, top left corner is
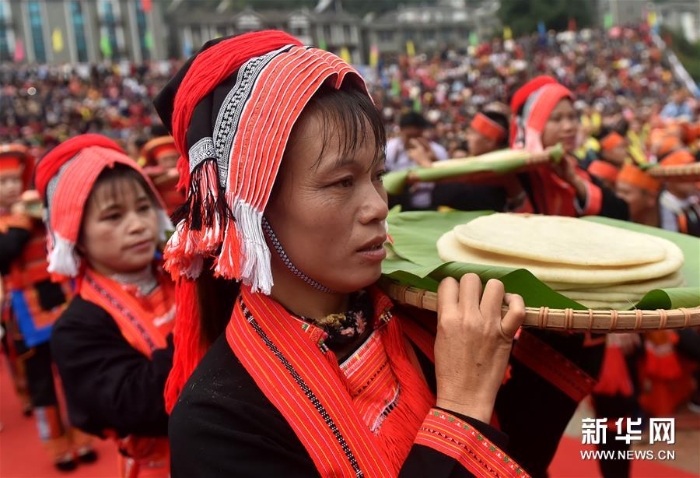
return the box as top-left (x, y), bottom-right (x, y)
top-left (0, 0), bottom-right (167, 63)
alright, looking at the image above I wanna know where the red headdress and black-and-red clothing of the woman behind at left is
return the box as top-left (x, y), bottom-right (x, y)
top-left (36, 135), bottom-right (175, 477)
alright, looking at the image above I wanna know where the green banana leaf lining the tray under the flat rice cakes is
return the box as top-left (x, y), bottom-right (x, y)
top-left (382, 210), bottom-right (700, 310)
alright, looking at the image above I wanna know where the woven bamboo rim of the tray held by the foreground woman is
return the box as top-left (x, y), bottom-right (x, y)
top-left (379, 277), bottom-right (700, 333)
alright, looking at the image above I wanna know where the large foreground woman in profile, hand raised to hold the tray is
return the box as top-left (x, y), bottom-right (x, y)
top-left (155, 31), bottom-right (526, 477)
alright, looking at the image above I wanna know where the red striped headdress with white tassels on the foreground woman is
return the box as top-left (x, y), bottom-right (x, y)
top-left (154, 31), bottom-right (366, 294)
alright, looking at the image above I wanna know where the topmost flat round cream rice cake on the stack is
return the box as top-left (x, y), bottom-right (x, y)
top-left (454, 213), bottom-right (666, 267)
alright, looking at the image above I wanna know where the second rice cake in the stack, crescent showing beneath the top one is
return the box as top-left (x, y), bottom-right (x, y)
top-left (437, 231), bottom-right (683, 284)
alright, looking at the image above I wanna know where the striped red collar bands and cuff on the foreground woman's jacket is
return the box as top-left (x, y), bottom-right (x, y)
top-left (226, 287), bottom-right (525, 477)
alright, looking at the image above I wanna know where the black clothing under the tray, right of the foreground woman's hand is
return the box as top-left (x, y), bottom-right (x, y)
top-left (495, 330), bottom-right (605, 478)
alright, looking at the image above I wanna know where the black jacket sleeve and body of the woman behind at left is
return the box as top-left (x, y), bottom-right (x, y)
top-left (51, 296), bottom-right (173, 437)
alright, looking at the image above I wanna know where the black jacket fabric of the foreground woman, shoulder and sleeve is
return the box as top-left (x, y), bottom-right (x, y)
top-left (169, 335), bottom-right (506, 478)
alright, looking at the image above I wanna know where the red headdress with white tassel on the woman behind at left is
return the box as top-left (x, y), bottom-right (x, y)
top-left (34, 134), bottom-right (172, 277)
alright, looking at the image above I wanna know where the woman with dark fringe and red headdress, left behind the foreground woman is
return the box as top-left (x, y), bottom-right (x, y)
top-left (36, 134), bottom-right (175, 478)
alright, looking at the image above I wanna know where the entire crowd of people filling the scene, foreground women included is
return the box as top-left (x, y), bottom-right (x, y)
top-left (0, 27), bottom-right (700, 477)
